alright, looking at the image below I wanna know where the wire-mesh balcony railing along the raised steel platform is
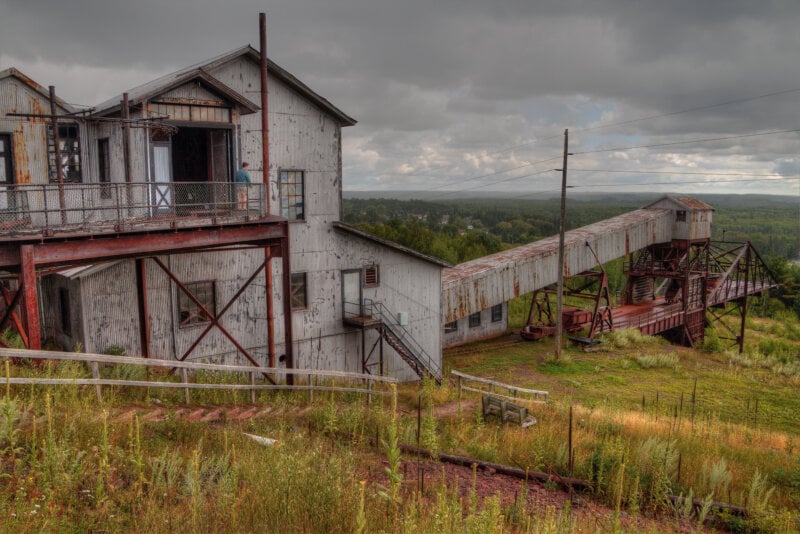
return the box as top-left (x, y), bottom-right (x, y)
top-left (0, 182), bottom-right (268, 235)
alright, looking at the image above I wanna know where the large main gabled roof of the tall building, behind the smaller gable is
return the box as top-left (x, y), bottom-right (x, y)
top-left (95, 45), bottom-right (356, 126)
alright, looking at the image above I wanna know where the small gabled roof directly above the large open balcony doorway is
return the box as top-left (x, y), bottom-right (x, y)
top-left (93, 69), bottom-right (261, 115)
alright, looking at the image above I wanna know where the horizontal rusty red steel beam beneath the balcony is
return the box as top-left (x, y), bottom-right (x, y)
top-left (0, 224), bottom-right (286, 267)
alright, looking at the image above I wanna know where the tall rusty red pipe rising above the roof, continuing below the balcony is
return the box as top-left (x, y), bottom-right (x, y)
top-left (258, 13), bottom-right (278, 367)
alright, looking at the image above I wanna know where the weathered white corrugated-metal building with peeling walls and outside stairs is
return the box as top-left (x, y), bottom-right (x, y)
top-left (0, 46), bottom-right (448, 379)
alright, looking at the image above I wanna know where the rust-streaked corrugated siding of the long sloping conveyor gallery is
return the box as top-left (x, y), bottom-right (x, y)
top-left (442, 209), bottom-right (672, 322)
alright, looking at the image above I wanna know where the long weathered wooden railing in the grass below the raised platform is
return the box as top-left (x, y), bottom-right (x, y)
top-left (0, 348), bottom-right (397, 404)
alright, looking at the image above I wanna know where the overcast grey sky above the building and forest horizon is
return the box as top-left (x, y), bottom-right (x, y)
top-left (0, 0), bottom-right (800, 200)
